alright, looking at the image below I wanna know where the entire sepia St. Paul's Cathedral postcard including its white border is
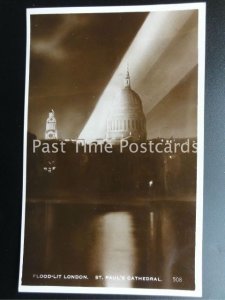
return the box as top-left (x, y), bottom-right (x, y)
top-left (19, 3), bottom-right (205, 296)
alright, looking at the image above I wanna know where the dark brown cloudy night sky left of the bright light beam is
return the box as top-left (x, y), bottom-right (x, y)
top-left (28, 12), bottom-right (148, 138)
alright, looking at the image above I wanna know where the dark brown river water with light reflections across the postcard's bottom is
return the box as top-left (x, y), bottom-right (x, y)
top-left (23, 200), bottom-right (195, 289)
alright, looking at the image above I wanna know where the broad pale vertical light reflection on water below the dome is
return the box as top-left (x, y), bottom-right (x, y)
top-left (95, 212), bottom-right (136, 287)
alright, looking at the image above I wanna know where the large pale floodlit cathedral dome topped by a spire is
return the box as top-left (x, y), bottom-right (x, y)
top-left (106, 72), bottom-right (146, 144)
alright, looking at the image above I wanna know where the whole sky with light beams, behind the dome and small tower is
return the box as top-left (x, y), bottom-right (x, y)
top-left (28, 10), bottom-right (200, 140)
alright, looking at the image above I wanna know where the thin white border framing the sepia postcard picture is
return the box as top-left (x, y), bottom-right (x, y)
top-left (18, 2), bottom-right (206, 297)
